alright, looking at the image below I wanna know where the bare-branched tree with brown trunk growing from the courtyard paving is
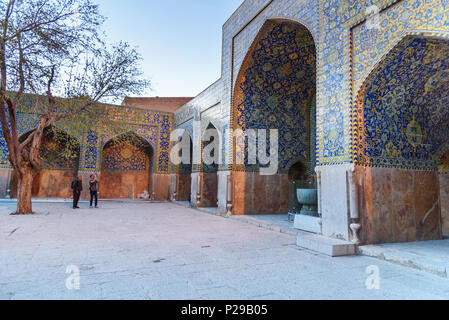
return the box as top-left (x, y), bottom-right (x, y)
top-left (0, 0), bottom-right (149, 213)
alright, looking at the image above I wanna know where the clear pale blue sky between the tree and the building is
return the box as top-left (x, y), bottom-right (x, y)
top-left (95, 0), bottom-right (243, 97)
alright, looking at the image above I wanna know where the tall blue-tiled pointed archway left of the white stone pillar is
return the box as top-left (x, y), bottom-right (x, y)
top-left (233, 20), bottom-right (316, 214)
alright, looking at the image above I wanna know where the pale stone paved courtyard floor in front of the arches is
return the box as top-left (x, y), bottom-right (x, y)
top-left (0, 202), bottom-right (449, 299)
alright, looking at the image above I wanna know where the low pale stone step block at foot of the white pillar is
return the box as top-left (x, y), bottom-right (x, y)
top-left (296, 234), bottom-right (357, 257)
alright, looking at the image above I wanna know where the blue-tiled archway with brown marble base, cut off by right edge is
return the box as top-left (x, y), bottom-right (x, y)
top-left (353, 36), bottom-right (449, 243)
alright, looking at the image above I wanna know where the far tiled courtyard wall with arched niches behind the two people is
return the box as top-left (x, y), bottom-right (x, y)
top-left (0, 97), bottom-right (178, 201)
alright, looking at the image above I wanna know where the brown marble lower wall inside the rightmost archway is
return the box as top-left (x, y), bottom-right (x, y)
top-left (356, 167), bottom-right (442, 244)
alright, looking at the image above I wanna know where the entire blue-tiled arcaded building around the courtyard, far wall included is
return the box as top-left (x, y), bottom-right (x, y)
top-left (0, 0), bottom-right (449, 248)
